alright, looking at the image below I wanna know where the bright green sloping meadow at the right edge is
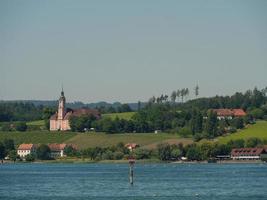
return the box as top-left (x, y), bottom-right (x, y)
top-left (217, 121), bottom-right (267, 143)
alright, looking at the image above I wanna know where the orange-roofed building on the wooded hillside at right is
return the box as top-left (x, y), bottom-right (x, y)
top-left (212, 109), bottom-right (246, 120)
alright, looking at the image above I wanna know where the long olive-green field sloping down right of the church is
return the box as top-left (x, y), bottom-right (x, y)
top-left (66, 133), bottom-right (191, 149)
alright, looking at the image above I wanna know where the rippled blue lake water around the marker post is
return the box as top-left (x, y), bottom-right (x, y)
top-left (0, 163), bottom-right (267, 200)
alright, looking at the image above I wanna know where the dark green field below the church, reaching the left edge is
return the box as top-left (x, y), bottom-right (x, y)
top-left (0, 131), bottom-right (77, 145)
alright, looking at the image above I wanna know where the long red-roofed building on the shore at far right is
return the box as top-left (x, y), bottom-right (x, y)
top-left (231, 148), bottom-right (267, 160)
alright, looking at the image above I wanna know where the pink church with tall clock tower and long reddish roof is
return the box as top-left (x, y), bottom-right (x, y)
top-left (50, 90), bottom-right (100, 131)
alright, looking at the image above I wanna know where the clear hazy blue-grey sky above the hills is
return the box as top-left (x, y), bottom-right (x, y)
top-left (0, 0), bottom-right (267, 103)
